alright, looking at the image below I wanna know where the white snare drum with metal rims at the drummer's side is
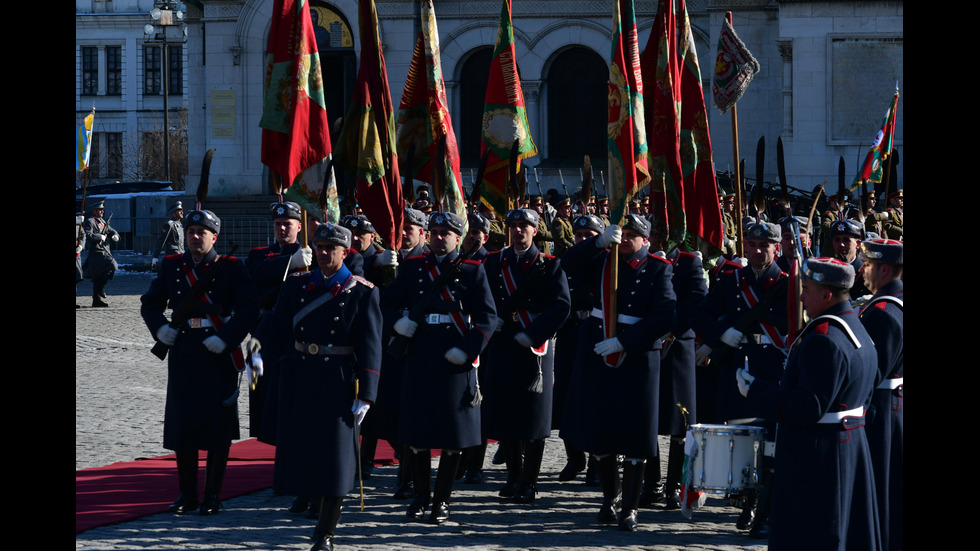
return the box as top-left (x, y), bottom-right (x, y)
top-left (689, 425), bottom-right (765, 494)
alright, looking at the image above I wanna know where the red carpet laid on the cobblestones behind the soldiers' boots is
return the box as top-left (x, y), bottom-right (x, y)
top-left (75, 438), bottom-right (395, 534)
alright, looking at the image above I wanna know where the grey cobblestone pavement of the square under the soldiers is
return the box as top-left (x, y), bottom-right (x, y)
top-left (75, 266), bottom-right (767, 551)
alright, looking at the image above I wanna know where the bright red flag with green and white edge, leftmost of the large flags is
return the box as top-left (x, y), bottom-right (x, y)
top-left (259, 0), bottom-right (330, 188)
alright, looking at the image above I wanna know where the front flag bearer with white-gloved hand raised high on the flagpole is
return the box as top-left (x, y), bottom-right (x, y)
top-left (561, 214), bottom-right (675, 531)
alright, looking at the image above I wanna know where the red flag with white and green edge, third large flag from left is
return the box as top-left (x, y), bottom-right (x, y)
top-left (397, 0), bottom-right (466, 220)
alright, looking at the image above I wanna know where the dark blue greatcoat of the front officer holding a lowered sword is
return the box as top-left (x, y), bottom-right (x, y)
top-left (258, 267), bottom-right (381, 496)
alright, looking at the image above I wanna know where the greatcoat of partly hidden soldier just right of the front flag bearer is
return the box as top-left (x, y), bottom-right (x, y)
top-left (660, 249), bottom-right (708, 436)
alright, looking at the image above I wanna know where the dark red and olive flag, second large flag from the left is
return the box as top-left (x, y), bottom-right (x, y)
top-left (337, 0), bottom-right (405, 249)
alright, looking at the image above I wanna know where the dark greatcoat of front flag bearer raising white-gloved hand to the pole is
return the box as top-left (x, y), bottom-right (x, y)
top-left (561, 237), bottom-right (675, 458)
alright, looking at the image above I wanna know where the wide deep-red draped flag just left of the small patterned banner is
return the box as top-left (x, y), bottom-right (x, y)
top-left (640, 0), bottom-right (723, 251)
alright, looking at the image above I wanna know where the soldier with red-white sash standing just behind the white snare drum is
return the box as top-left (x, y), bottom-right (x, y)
top-left (691, 222), bottom-right (787, 538)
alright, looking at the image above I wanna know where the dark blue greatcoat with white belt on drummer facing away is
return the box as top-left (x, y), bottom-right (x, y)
top-left (748, 302), bottom-right (881, 551)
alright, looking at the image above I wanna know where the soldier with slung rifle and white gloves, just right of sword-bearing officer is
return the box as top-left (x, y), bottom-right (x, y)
top-left (382, 212), bottom-right (496, 524)
